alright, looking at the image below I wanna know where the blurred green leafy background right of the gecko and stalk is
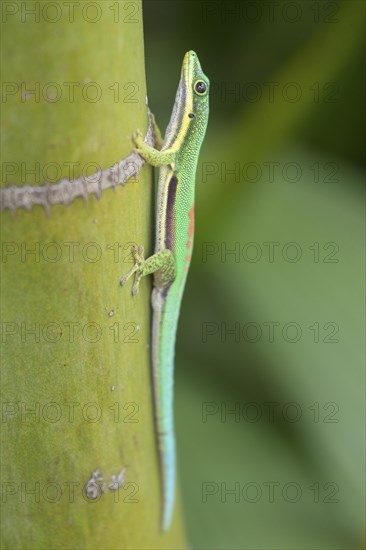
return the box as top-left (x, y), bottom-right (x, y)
top-left (143, 0), bottom-right (365, 549)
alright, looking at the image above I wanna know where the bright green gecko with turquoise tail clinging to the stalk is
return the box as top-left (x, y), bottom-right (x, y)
top-left (120, 51), bottom-right (210, 531)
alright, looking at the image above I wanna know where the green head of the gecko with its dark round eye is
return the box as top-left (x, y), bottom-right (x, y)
top-left (181, 50), bottom-right (210, 138)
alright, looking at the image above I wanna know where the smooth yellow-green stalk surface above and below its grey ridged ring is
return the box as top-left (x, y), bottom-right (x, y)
top-left (1, 1), bottom-right (185, 549)
